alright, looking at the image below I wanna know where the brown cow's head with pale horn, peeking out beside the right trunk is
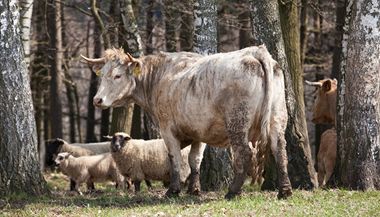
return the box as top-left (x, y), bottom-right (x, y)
top-left (306, 79), bottom-right (337, 124)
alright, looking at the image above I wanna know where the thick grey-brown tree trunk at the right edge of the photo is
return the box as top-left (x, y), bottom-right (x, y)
top-left (337, 0), bottom-right (380, 190)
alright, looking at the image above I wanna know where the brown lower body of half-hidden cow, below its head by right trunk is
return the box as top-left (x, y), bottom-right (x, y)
top-left (317, 128), bottom-right (336, 187)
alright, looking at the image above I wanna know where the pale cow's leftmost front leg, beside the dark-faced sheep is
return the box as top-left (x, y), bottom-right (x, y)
top-left (162, 133), bottom-right (182, 197)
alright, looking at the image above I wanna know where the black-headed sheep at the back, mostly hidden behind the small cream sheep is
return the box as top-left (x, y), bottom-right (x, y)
top-left (45, 138), bottom-right (111, 191)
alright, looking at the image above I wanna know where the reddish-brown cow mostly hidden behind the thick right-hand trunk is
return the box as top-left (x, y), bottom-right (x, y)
top-left (306, 79), bottom-right (337, 187)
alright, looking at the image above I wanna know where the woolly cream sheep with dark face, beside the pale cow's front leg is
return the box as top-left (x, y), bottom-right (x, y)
top-left (111, 133), bottom-right (205, 192)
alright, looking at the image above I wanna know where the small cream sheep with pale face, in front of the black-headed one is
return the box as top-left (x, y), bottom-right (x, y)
top-left (55, 152), bottom-right (124, 195)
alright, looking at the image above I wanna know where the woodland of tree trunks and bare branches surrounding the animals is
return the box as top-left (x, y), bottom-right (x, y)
top-left (0, 0), bottom-right (380, 214)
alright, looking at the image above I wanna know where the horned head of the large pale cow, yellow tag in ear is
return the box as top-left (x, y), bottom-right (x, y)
top-left (82, 48), bottom-right (142, 109)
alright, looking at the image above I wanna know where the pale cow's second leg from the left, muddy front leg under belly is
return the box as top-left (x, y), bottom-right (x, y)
top-left (187, 142), bottom-right (206, 195)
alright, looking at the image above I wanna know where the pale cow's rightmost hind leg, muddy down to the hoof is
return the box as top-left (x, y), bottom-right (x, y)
top-left (270, 132), bottom-right (292, 199)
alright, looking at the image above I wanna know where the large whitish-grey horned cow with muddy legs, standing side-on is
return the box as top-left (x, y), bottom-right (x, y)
top-left (84, 46), bottom-right (292, 199)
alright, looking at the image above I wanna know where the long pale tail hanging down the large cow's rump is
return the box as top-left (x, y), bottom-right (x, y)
top-left (258, 45), bottom-right (274, 143)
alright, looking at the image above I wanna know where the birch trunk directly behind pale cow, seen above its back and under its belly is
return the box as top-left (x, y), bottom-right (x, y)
top-left (194, 0), bottom-right (233, 191)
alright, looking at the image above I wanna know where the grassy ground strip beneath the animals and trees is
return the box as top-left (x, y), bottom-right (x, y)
top-left (0, 173), bottom-right (380, 217)
